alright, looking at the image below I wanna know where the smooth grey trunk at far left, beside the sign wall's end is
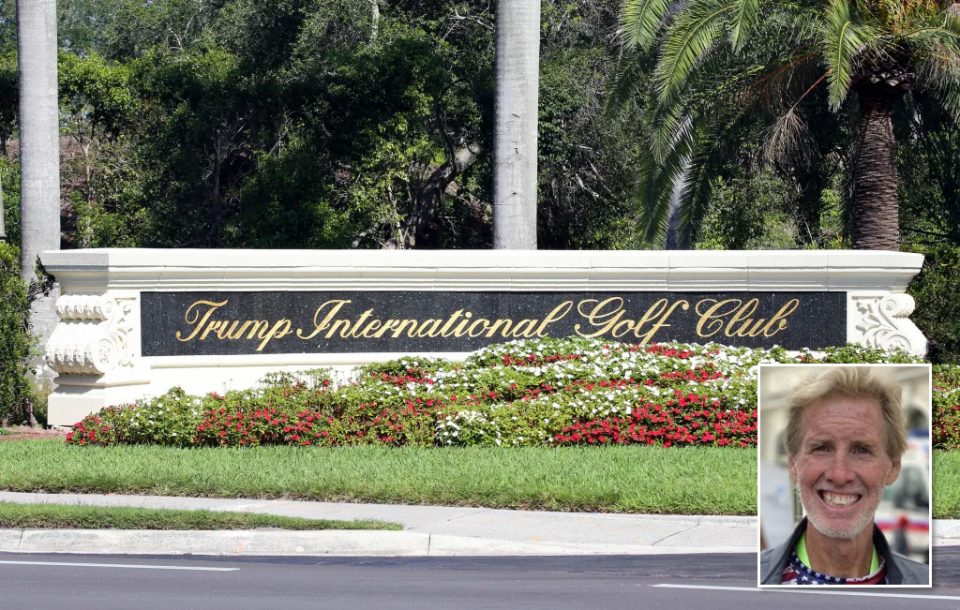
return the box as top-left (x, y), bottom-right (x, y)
top-left (17, 0), bottom-right (60, 423)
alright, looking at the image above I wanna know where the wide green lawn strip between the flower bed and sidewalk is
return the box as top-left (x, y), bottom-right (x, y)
top-left (0, 440), bottom-right (757, 515)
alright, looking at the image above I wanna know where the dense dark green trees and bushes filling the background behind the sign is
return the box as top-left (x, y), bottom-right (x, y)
top-left (0, 0), bottom-right (960, 419)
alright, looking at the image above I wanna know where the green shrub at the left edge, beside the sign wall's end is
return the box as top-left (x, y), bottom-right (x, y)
top-left (0, 243), bottom-right (31, 424)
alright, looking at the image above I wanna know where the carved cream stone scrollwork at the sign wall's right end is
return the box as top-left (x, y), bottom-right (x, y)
top-left (853, 294), bottom-right (927, 355)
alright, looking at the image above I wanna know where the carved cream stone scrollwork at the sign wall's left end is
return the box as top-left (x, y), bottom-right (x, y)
top-left (46, 295), bottom-right (134, 375)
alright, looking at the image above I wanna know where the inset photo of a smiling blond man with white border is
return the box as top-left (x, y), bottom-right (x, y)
top-left (757, 364), bottom-right (932, 587)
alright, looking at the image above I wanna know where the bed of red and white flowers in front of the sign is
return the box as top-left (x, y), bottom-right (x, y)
top-left (67, 339), bottom-right (944, 447)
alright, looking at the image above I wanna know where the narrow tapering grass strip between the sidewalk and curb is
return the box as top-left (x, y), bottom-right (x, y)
top-left (0, 502), bottom-right (403, 530)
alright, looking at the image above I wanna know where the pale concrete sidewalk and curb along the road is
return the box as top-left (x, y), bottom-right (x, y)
top-left (0, 492), bottom-right (960, 557)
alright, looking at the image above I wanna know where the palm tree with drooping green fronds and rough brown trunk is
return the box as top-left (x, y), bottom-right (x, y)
top-left (621, 0), bottom-right (960, 250)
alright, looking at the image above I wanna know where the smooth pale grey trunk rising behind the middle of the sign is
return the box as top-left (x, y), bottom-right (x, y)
top-left (493, 0), bottom-right (540, 250)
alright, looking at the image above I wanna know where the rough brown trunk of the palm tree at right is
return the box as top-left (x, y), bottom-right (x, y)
top-left (850, 86), bottom-right (900, 250)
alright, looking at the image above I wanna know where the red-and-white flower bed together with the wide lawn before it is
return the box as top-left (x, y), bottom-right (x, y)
top-left (0, 339), bottom-right (960, 517)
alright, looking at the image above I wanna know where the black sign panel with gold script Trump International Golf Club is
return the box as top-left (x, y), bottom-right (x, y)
top-left (141, 291), bottom-right (847, 356)
